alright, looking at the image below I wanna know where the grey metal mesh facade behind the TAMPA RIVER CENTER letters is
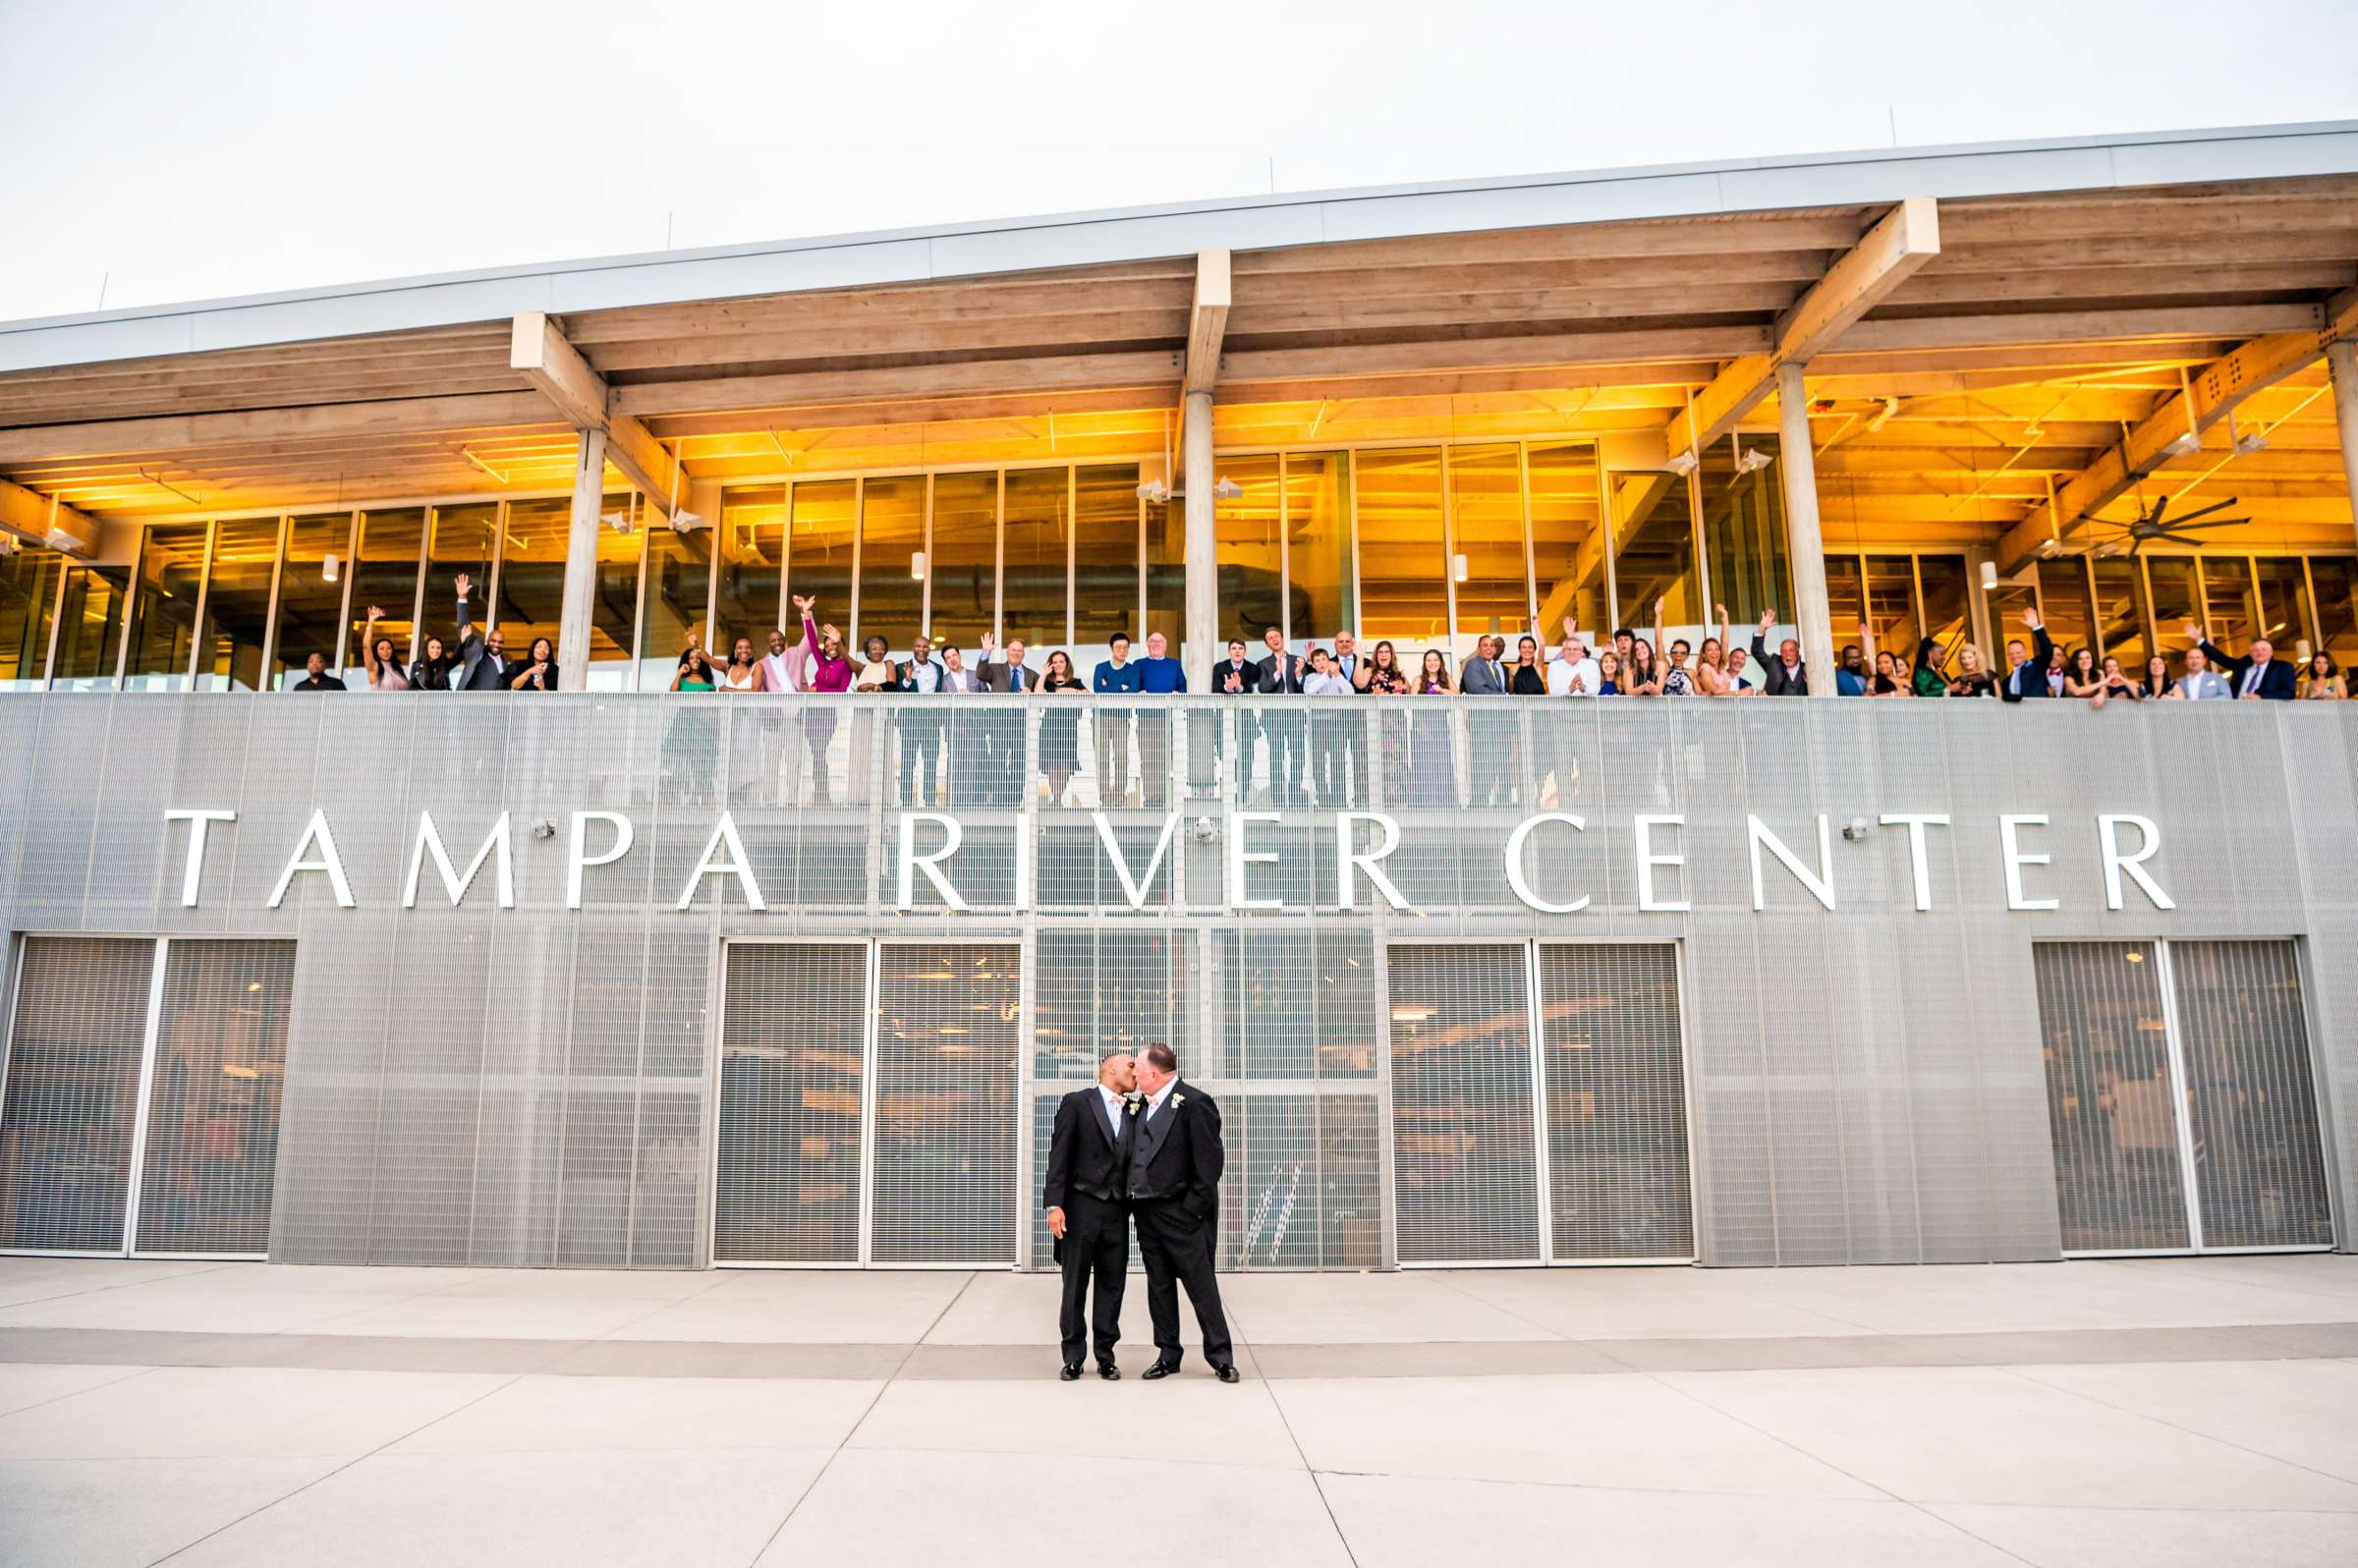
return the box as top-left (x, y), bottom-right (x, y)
top-left (0, 694), bottom-right (2358, 1266)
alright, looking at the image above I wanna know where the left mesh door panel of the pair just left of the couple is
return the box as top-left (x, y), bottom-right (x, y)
top-left (712, 943), bottom-right (868, 1263)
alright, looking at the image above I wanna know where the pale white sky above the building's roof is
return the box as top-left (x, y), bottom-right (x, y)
top-left (0, 0), bottom-right (2358, 320)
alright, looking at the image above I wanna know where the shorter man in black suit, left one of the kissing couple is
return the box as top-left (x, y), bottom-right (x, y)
top-left (1039, 1051), bottom-right (1139, 1381)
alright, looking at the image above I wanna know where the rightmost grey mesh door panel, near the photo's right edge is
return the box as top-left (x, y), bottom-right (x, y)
top-left (2169, 941), bottom-right (2334, 1248)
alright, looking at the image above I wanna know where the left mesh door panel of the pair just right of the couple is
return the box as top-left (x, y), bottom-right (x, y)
top-left (1386, 945), bottom-right (1540, 1263)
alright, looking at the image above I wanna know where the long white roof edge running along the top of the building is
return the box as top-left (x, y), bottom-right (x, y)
top-left (0, 120), bottom-right (2358, 370)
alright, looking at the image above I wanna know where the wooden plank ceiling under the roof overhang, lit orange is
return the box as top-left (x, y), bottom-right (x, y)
top-left (0, 177), bottom-right (2358, 563)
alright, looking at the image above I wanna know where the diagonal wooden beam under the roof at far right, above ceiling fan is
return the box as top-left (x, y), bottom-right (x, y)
top-left (1997, 288), bottom-right (2358, 573)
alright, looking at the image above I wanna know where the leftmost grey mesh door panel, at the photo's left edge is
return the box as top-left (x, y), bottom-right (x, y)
top-left (0, 936), bottom-right (155, 1252)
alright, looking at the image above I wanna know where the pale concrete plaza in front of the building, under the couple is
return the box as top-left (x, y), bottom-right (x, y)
top-left (0, 1257), bottom-right (2358, 1568)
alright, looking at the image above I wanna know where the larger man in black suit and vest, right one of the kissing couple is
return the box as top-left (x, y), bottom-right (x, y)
top-left (1130, 1039), bottom-right (1238, 1381)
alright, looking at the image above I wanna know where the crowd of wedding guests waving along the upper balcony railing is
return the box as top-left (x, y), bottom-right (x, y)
top-left (293, 576), bottom-right (2346, 809)
